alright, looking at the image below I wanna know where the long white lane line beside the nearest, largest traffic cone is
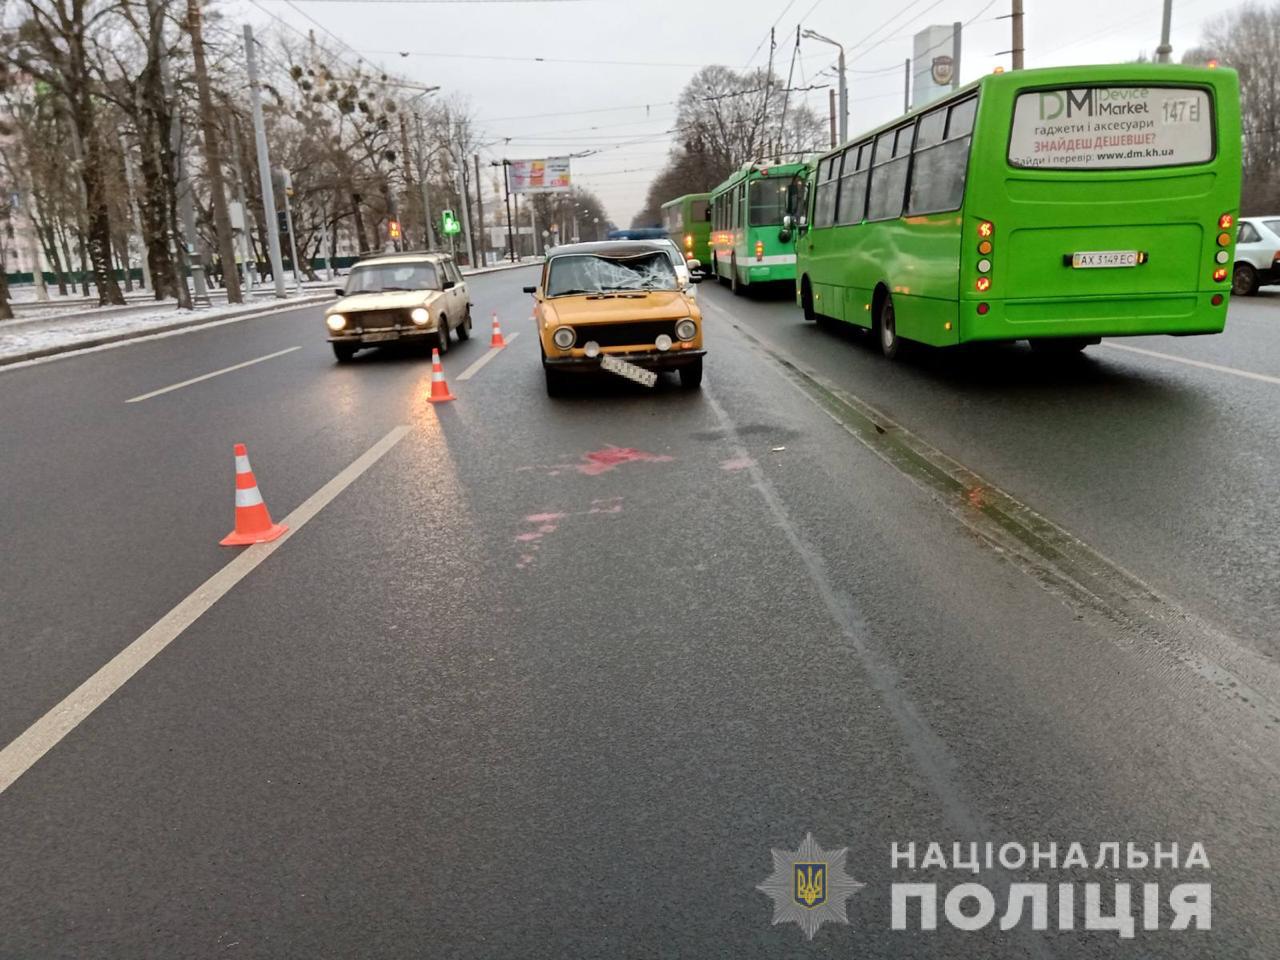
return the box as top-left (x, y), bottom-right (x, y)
top-left (0, 424), bottom-right (410, 794)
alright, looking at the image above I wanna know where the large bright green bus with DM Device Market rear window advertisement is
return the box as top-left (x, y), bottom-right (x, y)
top-left (796, 64), bottom-right (1240, 357)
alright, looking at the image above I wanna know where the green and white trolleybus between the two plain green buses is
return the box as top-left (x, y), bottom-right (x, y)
top-left (710, 160), bottom-right (809, 293)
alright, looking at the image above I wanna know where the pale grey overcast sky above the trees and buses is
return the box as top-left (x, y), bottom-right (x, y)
top-left (235, 0), bottom-right (1244, 223)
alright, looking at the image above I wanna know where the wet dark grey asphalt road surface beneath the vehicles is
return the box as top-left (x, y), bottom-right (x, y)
top-left (0, 270), bottom-right (1280, 960)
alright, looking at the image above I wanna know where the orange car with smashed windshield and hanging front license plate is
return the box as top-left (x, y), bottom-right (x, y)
top-left (525, 241), bottom-right (705, 397)
